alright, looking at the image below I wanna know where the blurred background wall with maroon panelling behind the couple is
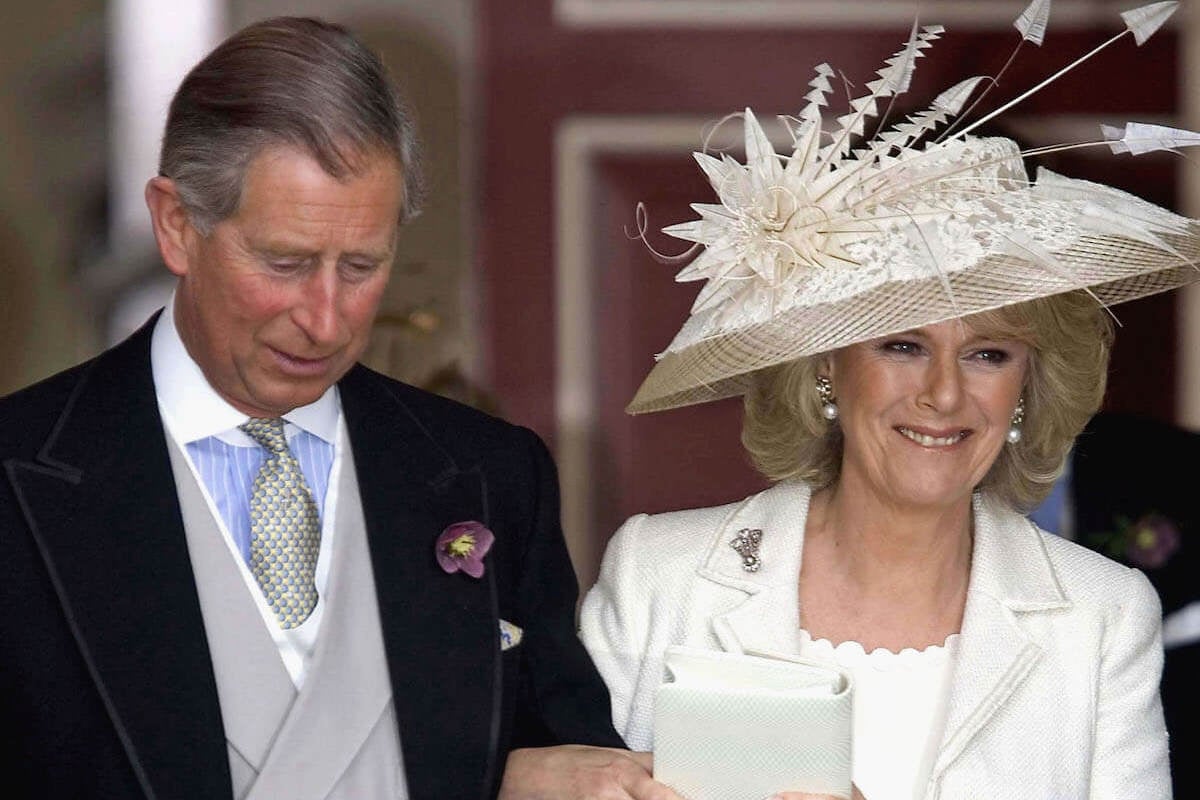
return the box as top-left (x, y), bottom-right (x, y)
top-left (0, 0), bottom-right (1200, 584)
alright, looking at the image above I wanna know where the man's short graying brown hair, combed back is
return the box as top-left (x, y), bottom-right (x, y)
top-left (158, 17), bottom-right (424, 235)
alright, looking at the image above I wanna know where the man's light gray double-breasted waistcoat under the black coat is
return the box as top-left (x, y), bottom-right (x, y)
top-left (167, 434), bottom-right (408, 800)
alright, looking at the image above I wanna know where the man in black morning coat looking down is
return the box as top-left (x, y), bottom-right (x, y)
top-left (0, 19), bottom-right (674, 800)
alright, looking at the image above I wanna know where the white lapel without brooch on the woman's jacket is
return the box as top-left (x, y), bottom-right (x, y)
top-left (931, 495), bottom-right (1070, 780)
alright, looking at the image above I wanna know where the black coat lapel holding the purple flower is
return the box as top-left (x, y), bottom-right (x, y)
top-left (340, 367), bottom-right (503, 800)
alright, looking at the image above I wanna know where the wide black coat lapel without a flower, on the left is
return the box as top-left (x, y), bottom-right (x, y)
top-left (5, 320), bottom-right (230, 800)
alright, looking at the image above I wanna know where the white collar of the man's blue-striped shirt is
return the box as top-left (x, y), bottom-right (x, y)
top-left (150, 293), bottom-right (342, 445)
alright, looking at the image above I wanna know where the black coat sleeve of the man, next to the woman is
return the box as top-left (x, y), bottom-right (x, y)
top-left (504, 431), bottom-right (623, 747)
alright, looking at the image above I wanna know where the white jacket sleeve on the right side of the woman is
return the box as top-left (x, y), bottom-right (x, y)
top-left (1088, 570), bottom-right (1171, 800)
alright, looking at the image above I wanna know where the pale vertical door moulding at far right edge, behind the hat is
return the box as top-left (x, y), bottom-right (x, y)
top-left (1176, 2), bottom-right (1200, 431)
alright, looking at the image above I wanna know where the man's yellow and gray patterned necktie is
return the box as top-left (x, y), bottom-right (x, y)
top-left (238, 419), bottom-right (320, 630)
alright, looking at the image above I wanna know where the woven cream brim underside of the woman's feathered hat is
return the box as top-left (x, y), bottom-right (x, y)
top-left (625, 231), bottom-right (1200, 414)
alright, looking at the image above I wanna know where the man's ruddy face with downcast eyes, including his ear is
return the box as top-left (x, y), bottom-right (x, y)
top-left (170, 145), bottom-right (403, 417)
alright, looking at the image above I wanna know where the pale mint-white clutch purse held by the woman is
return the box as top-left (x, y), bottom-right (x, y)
top-left (654, 646), bottom-right (853, 800)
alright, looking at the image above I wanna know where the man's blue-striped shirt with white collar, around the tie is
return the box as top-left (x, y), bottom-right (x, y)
top-left (150, 296), bottom-right (348, 690)
